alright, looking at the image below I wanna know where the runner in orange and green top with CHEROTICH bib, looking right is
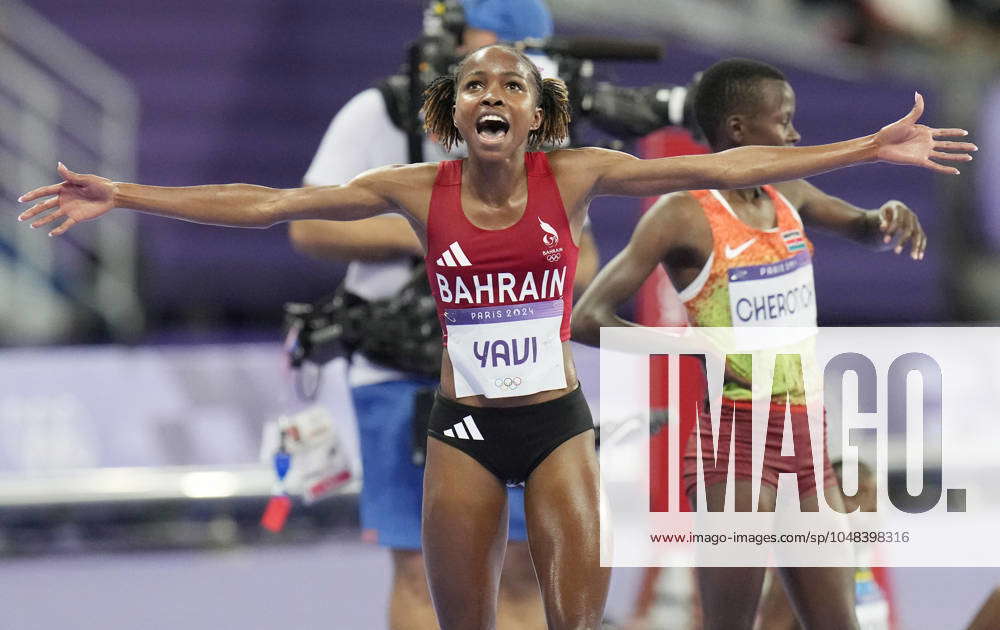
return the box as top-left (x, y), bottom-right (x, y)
top-left (572, 59), bottom-right (927, 630)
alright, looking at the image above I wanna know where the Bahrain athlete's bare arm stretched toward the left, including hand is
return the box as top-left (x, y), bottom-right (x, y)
top-left (18, 164), bottom-right (433, 236)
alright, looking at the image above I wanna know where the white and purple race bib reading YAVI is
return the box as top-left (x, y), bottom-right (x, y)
top-left (444, 300), bottom-right (566, 398)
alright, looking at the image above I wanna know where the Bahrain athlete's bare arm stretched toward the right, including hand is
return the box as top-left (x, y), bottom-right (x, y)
top-left (586, 94), bottom-right (977, 197)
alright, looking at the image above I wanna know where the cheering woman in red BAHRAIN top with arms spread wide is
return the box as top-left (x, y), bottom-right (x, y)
top-left (13, 46), bottom-right (975, 630)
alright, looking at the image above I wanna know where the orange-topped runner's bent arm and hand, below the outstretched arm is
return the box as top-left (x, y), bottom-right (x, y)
top-left (776, 180), bottom-right (927, 260)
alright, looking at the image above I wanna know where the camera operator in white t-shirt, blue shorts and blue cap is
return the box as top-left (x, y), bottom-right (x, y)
top-left (290, 0), bottom-right (597, 630)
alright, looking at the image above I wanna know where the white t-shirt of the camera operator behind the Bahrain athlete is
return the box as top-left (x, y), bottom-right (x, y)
top-left (303, 88), bottom-right (464, 387)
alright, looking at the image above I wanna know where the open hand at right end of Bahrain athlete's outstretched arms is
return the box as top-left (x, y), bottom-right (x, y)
top-left (875, 93), bottom-right (979, 175)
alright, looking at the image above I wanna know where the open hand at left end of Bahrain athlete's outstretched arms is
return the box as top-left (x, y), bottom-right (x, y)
top-left (17, 162), bottom-right (115, 236)
